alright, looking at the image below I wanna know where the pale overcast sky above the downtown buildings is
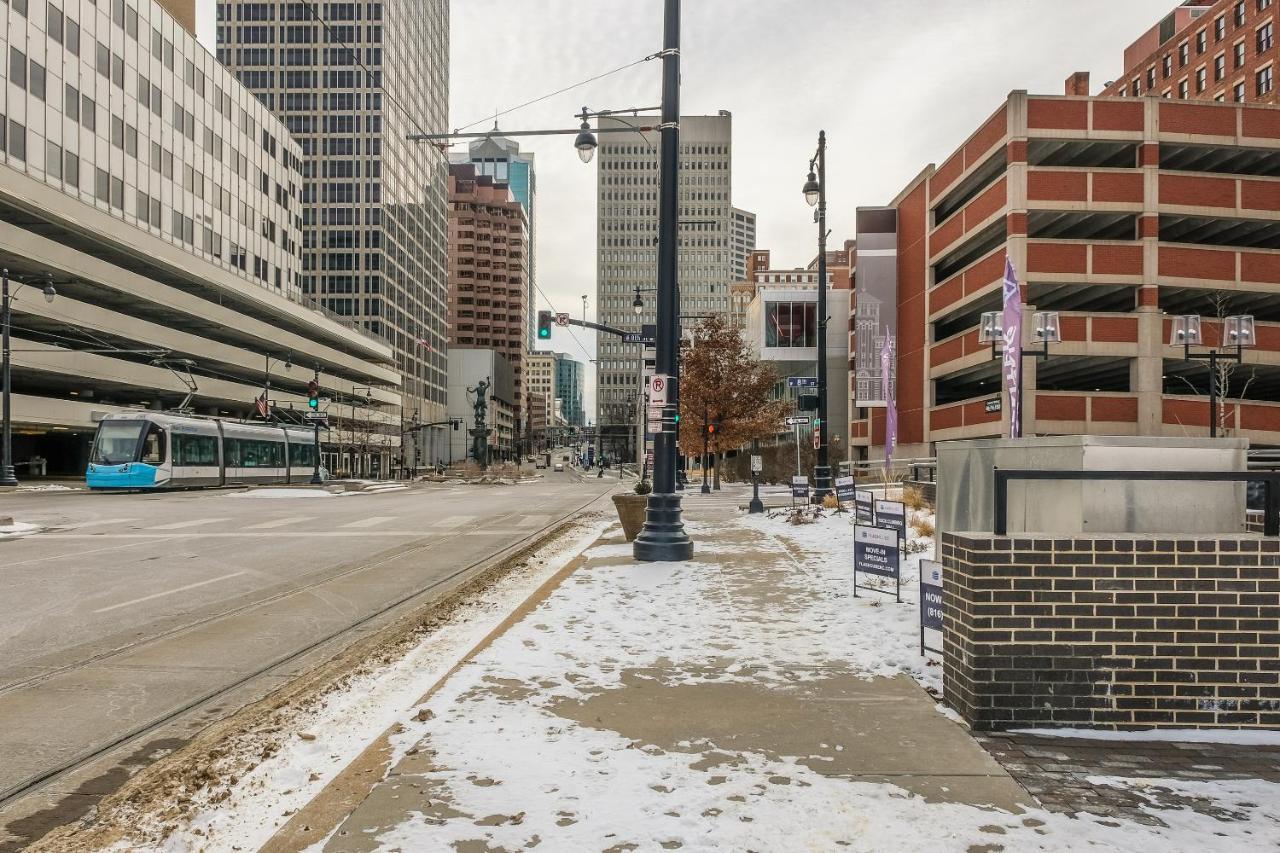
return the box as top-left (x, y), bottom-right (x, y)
top-left (192, 0), bottom-right (1178, 416)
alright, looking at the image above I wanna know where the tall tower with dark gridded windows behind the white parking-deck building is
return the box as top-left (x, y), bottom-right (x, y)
top-left (218, 0), bottom-right (449, 448)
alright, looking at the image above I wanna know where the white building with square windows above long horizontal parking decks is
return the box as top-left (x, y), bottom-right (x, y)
top-left (0, 0), bottom-right (399, 476)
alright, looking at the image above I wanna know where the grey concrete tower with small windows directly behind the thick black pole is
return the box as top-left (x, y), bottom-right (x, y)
top-left (595, 110), bottom-right (733, 439)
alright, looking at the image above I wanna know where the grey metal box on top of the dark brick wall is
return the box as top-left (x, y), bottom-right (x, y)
top-left (937, 435), bottom-right (1249, 535)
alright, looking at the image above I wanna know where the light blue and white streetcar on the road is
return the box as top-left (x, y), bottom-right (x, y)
top-left (84, 411), bottom-right (316, 489)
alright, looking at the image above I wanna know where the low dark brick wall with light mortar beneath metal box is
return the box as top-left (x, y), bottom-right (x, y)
top-left (941, 533), bottom-right (1280, 730)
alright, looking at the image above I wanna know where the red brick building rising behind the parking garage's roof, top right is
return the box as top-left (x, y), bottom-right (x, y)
top-left (1095, 0), bottom-right (1280, 104)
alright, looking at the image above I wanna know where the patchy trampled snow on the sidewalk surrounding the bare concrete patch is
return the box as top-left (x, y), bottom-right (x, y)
top-left (350, 515), bottom-right (1280, 853)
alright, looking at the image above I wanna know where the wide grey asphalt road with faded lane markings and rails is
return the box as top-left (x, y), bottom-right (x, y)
top-left (0, 470), bottom-right (618, 838)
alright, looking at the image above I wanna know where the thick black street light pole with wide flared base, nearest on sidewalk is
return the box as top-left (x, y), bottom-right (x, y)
top-left (632, 0), bottom-right (694, 562)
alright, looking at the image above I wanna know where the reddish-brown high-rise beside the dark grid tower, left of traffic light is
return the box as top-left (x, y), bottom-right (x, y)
top-left (448, 163), bottom-right (529, 411)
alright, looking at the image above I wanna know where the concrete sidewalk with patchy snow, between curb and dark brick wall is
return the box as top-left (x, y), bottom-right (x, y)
top-left (70, 488), bottom-right (1280, 853)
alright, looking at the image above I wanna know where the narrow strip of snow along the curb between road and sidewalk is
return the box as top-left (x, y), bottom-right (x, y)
top-left (111, 514), bottom-right (604, 853)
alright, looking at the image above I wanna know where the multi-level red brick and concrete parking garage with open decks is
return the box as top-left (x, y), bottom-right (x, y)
top-left (850, 92), bottom-right (1280, 457)
